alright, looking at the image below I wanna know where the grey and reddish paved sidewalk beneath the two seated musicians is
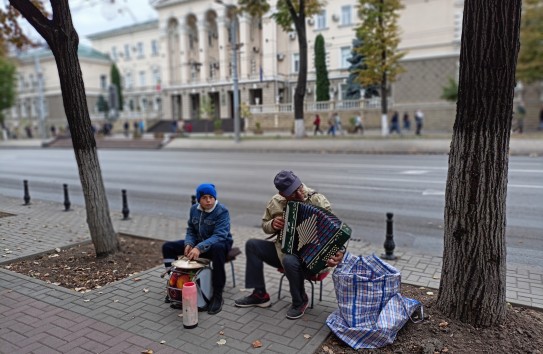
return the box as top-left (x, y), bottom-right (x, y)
top-left (0, 198), bottom-right (543, 354)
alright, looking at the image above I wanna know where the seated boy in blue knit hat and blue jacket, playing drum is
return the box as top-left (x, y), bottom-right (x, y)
top-left (162, 183), bottom-right (234, 315)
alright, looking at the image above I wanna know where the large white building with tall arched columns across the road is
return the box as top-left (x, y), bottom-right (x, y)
top-left (6, 0), bottom-right (535, 134)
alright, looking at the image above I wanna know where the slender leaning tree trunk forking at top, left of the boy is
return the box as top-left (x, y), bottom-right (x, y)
top-left (10, 0), bottom-right (120, 257)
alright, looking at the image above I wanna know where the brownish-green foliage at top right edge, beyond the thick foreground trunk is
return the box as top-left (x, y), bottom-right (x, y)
top-left (517, 0), bottom-right (543, 84)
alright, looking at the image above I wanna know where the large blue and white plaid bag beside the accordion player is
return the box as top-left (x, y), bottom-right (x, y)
top-left (326, 253), bottom-right (423, 349)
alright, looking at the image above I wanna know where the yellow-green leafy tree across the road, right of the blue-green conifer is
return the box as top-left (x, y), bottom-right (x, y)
top-left (356, 0), bottom-right (405, 114)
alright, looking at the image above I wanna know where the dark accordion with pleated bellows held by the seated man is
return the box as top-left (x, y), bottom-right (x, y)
top-left (279, 201), bottom-right (352, 274)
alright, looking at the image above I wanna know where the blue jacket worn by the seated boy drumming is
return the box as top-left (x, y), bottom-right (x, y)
top-left (185, 202), bottom-right (233, 253)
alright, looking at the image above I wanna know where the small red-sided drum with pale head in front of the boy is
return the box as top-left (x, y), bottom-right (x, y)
top-left (166, 259), bottom-right (213, 308)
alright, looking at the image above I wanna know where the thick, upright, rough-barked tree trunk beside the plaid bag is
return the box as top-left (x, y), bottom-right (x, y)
top-left (437, 0), bottom-right (521, 327)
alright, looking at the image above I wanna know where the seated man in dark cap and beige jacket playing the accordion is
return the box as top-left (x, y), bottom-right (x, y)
top-left (235, 170), bottom-right (345, 320)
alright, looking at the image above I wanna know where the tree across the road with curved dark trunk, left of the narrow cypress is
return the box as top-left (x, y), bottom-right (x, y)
top-left (238, 0), bottom-right (323, 138)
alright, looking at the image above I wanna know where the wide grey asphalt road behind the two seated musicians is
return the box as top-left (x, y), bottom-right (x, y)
top-left (0, 149), bottom-right (543, 266)
